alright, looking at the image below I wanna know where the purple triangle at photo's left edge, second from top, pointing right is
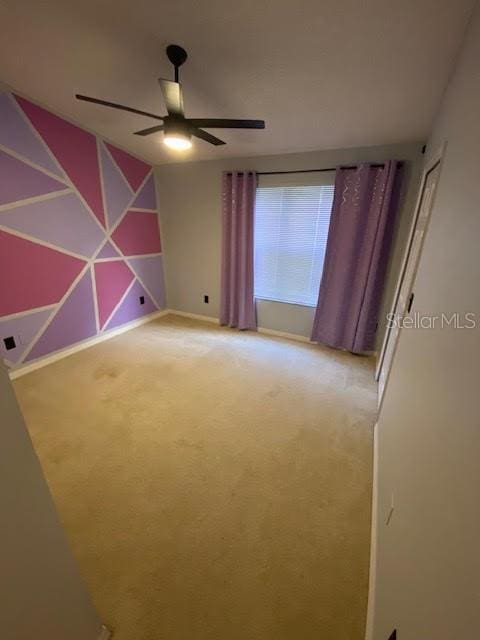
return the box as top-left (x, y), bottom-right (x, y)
top-left (0, 151), bottom-right (67, 204)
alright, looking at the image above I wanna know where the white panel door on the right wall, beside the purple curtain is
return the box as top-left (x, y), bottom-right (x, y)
top-left (376, 161), bottom-right (440, 406)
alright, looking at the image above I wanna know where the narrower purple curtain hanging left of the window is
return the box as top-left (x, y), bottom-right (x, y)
top-left (220, 171), bottom-right (257, 329)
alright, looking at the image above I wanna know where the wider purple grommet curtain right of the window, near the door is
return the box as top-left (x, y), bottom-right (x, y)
top-left (312, 160), bottom-right (402, 353)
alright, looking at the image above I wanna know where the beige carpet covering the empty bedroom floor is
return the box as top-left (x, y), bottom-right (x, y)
top-left (15, 317), bottom-right (375, 640)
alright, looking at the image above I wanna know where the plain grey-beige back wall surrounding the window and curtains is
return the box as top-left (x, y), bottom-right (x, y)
top-left (156, 143), bottom-right (423, 348)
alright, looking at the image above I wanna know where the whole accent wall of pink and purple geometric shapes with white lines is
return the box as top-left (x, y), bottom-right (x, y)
top-left (0, 92), bottom-right (165, 366)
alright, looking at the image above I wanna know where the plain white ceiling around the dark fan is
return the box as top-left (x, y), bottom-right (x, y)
top-left (0, 0), bottom-right (473, 164)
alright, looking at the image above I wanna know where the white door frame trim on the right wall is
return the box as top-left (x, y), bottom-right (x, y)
top-left (375, 142), bottom-right (447, 400)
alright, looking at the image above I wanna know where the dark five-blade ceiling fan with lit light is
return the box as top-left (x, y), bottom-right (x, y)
top-left (75, 44), bottom-right (265, 150)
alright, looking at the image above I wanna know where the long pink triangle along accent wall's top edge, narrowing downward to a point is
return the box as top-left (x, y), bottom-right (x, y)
top-left (16, 96), bottom-right (105, 226)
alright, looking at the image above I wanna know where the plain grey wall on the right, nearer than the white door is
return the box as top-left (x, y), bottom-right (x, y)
top-left (374, 2), bottom-right (480, 640)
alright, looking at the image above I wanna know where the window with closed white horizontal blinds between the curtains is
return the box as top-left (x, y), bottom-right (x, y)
top-left (254, 174), bottom-right (334, 306)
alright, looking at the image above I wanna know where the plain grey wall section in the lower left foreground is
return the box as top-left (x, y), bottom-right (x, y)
top-left (0, 362), bottom-right (100, 640)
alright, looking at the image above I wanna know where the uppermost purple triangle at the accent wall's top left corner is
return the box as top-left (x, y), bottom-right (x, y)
top-left (0, 93), bottom-right (63, 178)
